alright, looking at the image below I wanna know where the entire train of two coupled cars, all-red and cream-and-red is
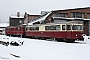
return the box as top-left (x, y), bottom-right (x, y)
top-left (6, 22), bottom-right (83, 41)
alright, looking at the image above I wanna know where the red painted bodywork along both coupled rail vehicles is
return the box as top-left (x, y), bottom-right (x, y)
top-left (6, 26), bottom-right (83, 40)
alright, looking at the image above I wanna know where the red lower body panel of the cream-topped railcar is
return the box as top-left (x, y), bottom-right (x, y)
top-left (26, 31), bottom-right (83, 40)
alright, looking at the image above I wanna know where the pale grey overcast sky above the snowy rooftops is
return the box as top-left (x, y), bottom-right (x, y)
top-left (0, 0), bottom-right (90, 22)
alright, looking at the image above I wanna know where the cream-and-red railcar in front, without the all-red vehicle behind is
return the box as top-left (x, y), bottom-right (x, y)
top-left (25, 22), bottom-right (83, 41)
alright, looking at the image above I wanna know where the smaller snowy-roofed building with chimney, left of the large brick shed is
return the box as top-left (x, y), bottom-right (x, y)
top-left (9, 12), bottom-right (41, 26)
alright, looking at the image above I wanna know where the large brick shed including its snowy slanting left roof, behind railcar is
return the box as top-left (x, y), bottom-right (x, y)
top-left (29, 7), bottom-right (90, 35)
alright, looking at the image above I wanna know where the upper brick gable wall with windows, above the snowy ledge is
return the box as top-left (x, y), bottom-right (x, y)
top-left (46, 7), bottom-right (90, 22)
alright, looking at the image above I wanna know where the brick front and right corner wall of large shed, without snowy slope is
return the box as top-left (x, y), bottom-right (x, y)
top-left (45, 7), bottom-right (90, 35)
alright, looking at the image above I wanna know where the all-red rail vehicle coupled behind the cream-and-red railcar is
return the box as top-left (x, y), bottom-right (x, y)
top-left (6, 25), bottom-right (25, 36)
